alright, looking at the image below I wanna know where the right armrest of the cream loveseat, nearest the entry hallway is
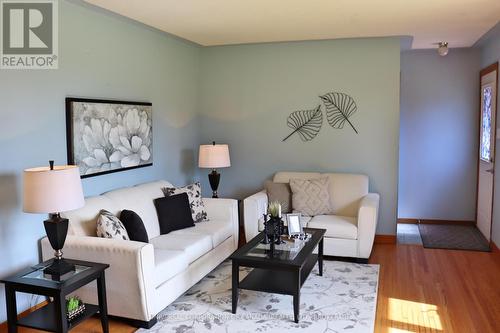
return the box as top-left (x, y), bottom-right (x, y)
top-left (358, 193), bottom-right (380, 259)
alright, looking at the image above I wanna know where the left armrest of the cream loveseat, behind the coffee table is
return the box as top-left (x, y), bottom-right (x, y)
top-left (243, 190), bottom-right (268, 242)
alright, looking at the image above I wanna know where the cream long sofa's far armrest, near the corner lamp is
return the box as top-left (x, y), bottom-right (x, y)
top-left (203, 198), bottom-right (240, 248)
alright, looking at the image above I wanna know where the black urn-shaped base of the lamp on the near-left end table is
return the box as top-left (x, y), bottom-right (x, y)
top-left (43, 214), bottom-right (75, 280)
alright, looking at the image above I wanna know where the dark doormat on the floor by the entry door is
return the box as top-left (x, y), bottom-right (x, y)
top-left (418, 224), bottom-right (490, 252)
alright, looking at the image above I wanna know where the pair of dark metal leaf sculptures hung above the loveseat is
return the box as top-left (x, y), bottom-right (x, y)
top-left (282, 92), bottom-right (358, 142)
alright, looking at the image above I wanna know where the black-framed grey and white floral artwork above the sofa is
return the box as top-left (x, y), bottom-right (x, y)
top-left (66, 98), bottom-right (153, 178)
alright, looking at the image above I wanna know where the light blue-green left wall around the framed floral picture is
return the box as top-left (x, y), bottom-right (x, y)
top-left (0, 1), bottom-right (199, 322)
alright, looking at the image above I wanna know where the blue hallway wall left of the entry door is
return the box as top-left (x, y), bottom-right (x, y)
top-left (398, 48), bottom-right (480, 221)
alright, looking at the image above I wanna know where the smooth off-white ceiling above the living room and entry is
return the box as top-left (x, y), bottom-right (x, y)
top-left (85, 0), bottom-right (500, 48)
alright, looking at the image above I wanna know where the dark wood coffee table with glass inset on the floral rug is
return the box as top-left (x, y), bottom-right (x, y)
top-left (229, 228), bottom-right (326, 323)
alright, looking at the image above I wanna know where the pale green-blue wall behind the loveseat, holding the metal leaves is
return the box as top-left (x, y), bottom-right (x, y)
top-left (199, 38), bottom-right (400, 234)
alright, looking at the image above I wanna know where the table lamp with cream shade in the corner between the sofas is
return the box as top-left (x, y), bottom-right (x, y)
top-left (198, 142), bottom-right (231, 198)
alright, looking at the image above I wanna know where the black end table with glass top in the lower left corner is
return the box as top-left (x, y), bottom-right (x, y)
top-left (0, 259), bottom-right (109, 333)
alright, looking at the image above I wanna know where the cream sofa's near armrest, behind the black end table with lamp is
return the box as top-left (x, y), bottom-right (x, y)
top-left (41, 236), bottom-right (156, 321)
